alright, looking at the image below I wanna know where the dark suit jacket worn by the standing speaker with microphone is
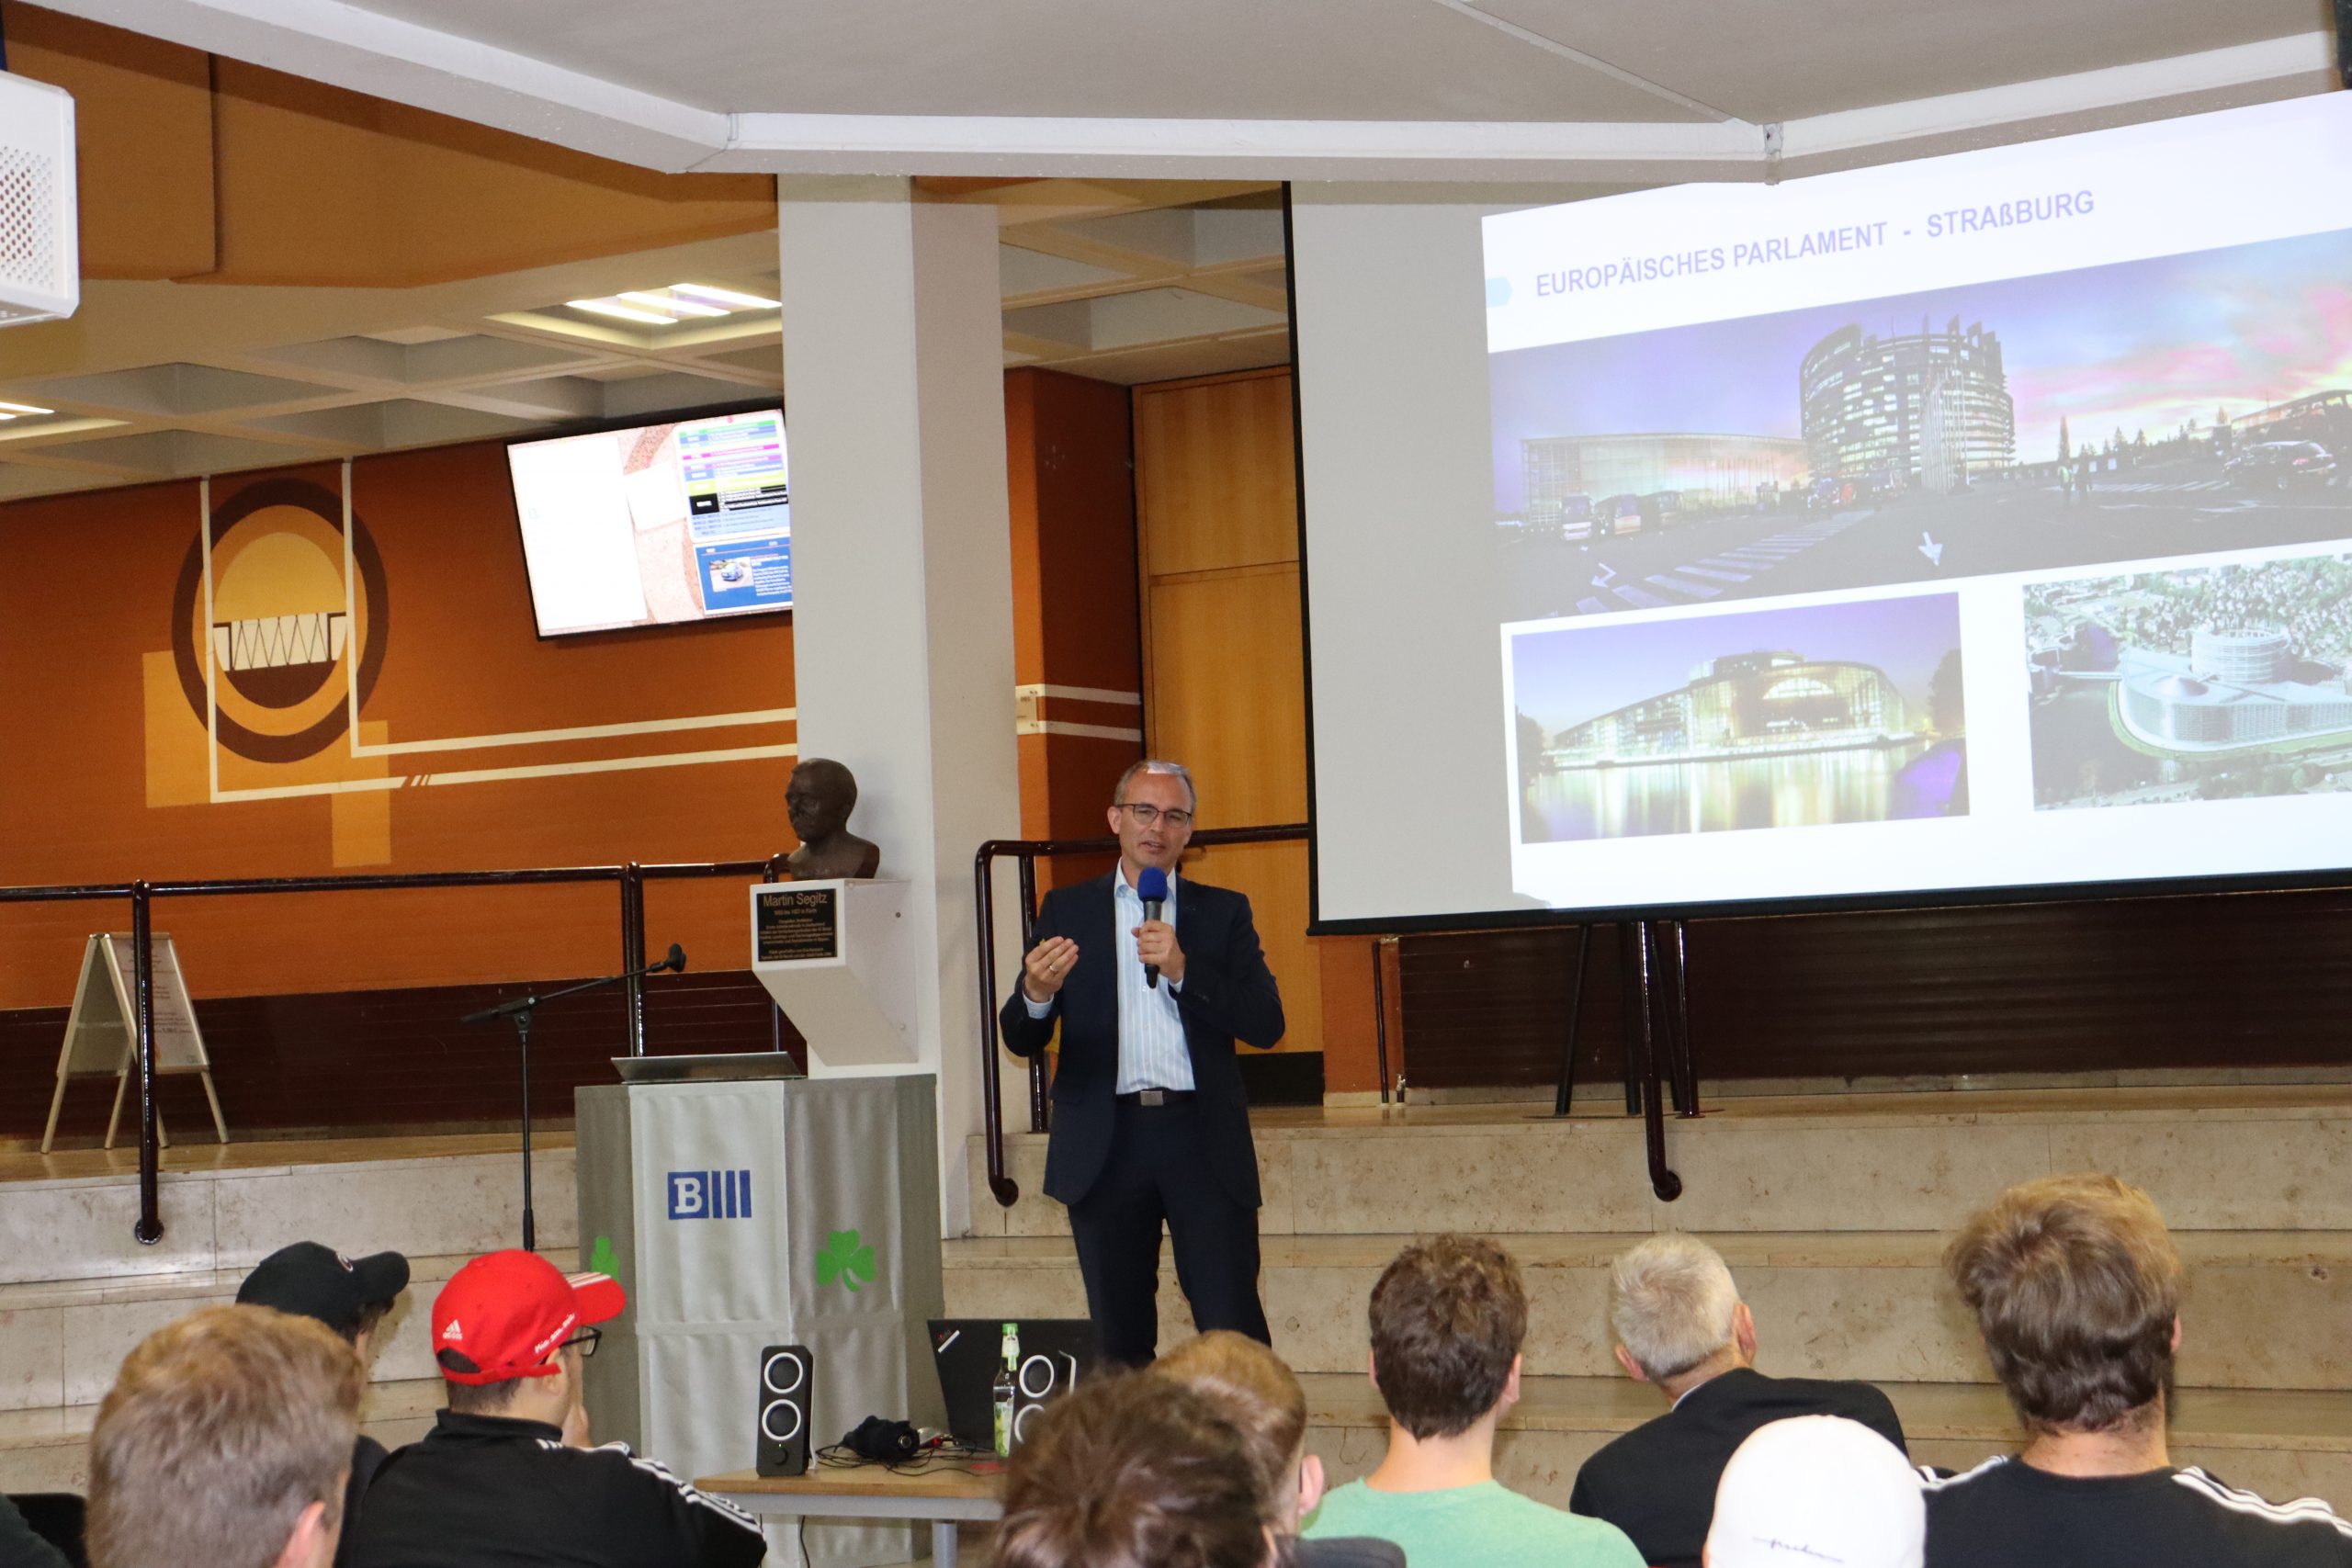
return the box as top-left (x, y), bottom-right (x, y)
top-left (1000, 870), bottom-right (1282, 1208)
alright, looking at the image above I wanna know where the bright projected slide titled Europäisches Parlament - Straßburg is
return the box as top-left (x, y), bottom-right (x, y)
top-left (1484, 88), bottom-right (2352, 921)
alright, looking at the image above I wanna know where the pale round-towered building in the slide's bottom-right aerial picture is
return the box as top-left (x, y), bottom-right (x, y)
top-left (2120, 627), bottom-right (2352, 752)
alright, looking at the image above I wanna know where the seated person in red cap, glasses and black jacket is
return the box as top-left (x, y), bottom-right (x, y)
top-left (350, 1251), bottom-right (767, 1568)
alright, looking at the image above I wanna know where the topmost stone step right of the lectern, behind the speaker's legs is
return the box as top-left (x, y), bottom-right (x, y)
top-left (967, 1084), bottom-right (2352, 1236)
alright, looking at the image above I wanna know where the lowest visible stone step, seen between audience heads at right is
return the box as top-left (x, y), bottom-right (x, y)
top-left (1301, 1373), bottom-right (2352, 1506)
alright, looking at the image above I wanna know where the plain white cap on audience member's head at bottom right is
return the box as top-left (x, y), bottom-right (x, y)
top-left (1705, 1416), bottom-right (1927, 1568)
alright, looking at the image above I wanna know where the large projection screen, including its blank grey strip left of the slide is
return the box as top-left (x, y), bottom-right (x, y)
top-left (1291, 94), bottom-right (2352, 931)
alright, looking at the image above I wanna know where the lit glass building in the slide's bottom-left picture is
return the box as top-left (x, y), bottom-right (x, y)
top-left (1545, 651), bottom-right (1915, 769)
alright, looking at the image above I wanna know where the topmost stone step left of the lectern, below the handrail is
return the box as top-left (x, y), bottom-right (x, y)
top-left (0, 1134), bottom-right (579, 1297)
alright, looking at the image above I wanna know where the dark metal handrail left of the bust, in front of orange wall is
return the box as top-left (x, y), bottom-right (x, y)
top-left (0, 853), bottom-right (783, 1246)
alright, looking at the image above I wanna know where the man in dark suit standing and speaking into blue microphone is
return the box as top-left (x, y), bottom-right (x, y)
top-left (1002, 761), bottom-right (1282, 1366)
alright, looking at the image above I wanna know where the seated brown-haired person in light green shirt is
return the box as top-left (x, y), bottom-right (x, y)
top-left (1303, 1236), bottom-right (1642, 1568)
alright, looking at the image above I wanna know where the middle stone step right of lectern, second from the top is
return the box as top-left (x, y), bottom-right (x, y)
top-left (945, 1232), bottom-right (2352, 1389)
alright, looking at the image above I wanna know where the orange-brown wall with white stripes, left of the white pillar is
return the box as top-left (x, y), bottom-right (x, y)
top-left (0, 445), bottom-right (793, 1009)
